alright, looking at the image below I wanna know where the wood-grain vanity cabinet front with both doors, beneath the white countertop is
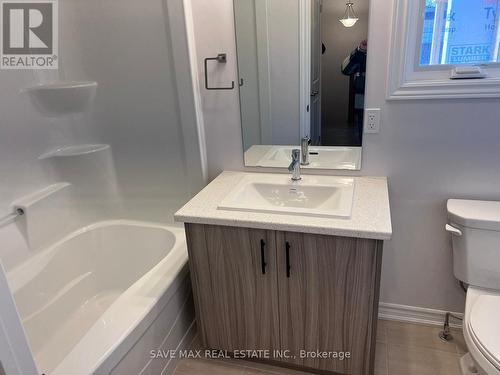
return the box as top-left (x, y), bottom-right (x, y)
top-left (186, 223), bottom-right (382, 375)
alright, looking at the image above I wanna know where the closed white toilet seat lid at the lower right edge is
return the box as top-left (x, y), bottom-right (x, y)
top-left (469, 295), bottom-right (500, 370)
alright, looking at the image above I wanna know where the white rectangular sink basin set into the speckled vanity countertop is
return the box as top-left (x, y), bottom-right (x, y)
top-left (218, 174), bottom-right (354, 217)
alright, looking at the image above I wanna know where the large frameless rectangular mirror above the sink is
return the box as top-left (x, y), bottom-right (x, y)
top-left (234, 0), bottom-right (369, 170)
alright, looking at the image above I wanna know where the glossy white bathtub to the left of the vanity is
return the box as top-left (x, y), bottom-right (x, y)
top-left (8, 220), bottom-right (194, 375)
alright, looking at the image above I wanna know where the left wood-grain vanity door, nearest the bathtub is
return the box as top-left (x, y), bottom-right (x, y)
top-left (186, 224), bottom-right (279, 352)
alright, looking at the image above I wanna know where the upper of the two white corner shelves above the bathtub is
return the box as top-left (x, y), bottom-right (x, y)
top-left (22, 81), bottom-right (97, 117)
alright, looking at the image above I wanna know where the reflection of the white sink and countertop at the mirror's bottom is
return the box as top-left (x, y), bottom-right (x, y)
top-left (257, 146), bottom-right (361, 170)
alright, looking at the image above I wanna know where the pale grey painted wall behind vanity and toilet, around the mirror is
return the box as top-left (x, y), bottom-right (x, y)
top-left (188, 0), bottom-right (500, 311)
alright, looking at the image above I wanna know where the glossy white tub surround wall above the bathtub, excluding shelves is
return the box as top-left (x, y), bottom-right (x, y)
top-left (0, 0), bottom-right (203, 369)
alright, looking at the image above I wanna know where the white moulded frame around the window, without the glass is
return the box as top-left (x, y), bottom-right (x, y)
top-left (387, 0), bottom-right (500, 100)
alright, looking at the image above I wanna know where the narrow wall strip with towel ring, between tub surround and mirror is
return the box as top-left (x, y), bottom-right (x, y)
top-left (185, 0), bottom-right (243, 178)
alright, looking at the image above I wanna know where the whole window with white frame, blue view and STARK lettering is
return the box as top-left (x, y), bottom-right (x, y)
top-left (388, 0), bottom-right (500, 99)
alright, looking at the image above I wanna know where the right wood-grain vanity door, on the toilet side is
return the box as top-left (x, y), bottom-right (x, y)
top-left (276, 232), bottom-right (382, 375)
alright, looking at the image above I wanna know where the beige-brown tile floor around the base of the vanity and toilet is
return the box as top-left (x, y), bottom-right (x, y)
top-left (175, 320), bottom-right (466, 375)
